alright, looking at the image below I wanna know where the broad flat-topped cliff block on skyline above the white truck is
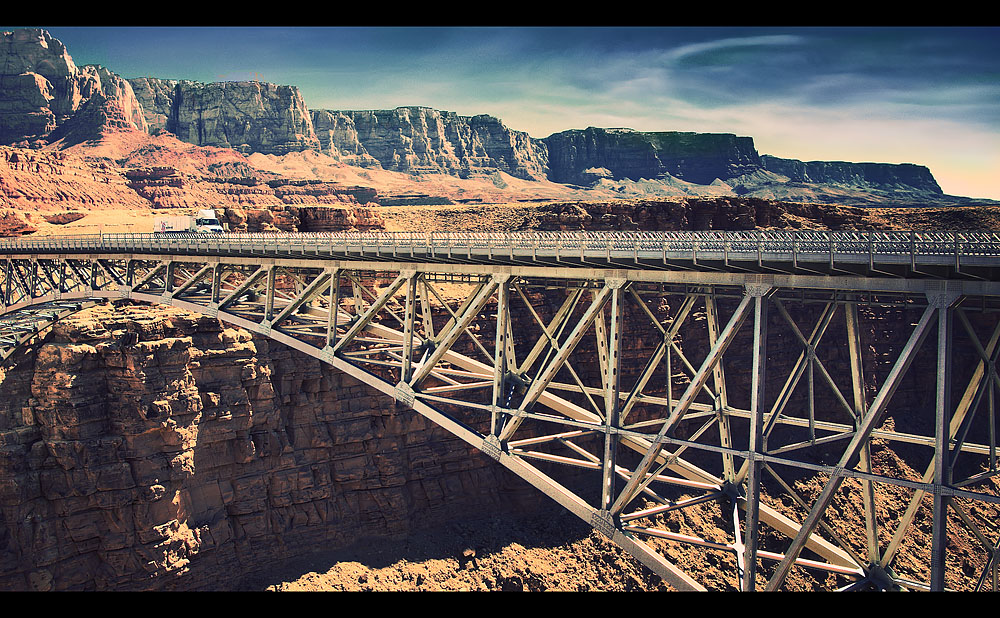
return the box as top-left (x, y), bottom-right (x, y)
top-left (166, 82), bottom-right (319, 154)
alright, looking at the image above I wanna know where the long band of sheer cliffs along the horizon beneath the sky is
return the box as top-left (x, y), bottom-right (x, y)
top-left (0, 29), bottom-right (961, 203)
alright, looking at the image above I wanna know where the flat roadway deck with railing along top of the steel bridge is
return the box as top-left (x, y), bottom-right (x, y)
top-left (0, 231), bottom-right (1000, 281)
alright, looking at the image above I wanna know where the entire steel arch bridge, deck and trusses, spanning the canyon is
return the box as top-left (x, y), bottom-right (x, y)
top-left (0, 232), bottom-right (1000, 590)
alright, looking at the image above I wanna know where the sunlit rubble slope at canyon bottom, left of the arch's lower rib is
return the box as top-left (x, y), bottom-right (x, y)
top-left (242, 510), bottom-right (669, 592)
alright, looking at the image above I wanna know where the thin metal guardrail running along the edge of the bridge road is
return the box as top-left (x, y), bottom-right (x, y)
top-left (0, 230), bottom-right (1000, 259)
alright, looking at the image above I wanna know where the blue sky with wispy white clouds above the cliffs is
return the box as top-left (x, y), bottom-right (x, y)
top-left (11, 25), bottom-right (1000, 199)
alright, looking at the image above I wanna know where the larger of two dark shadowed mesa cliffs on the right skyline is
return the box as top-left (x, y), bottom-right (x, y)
top-left (545, 127), bottom-right (760, 185)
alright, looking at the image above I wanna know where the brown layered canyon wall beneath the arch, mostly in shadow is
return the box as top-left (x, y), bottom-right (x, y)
top-left (0, 306), bottom-right (533, 590)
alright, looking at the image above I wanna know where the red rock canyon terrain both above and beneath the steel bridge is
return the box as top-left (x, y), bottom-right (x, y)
top-left (0, 29), bottom-right (1000, 591)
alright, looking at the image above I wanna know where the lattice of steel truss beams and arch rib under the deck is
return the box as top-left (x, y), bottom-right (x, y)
top-left (0, 231), bottom-right (1000, 589)
